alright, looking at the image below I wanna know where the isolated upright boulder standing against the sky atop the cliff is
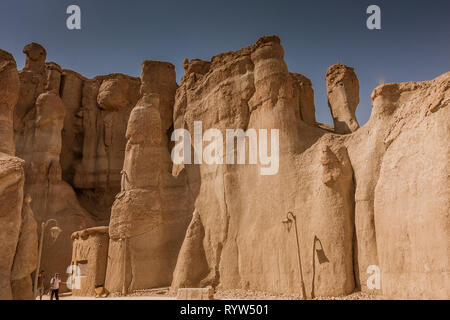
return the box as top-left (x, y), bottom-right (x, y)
top-left (325, 63), bottom-right (359, 133)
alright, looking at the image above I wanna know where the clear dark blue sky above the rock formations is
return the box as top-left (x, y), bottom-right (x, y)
top-left (0, 0), bottom-right (450, 124)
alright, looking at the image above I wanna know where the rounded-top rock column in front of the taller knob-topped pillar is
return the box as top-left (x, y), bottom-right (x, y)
top-left (23, 92), bottom-right (94, 286)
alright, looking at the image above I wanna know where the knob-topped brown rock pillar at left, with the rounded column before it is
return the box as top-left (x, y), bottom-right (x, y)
top-left (14, 43), bottom-right (94, 288)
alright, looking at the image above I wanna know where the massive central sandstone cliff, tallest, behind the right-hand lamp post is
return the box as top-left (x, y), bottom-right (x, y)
top-left (172, 36), bottom-right (354, 295)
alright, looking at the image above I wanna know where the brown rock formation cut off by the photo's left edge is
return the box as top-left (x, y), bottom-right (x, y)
top-left (0, 50), bottom-right (37, 299)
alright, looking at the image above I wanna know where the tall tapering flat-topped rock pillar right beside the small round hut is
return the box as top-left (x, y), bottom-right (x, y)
top-left (106, 61), bottom-right (193, 292)
